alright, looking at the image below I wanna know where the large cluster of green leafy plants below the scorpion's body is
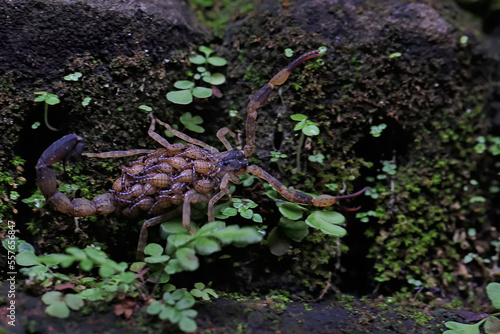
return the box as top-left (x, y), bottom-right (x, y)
top-left (16, 220), bottom-right (262, 332)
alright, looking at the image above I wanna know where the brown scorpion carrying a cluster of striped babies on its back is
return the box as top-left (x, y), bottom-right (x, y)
top-left (36, 50), bottom-right (365, 252)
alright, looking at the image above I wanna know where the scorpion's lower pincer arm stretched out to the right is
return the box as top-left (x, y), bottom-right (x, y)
top-left (247, 165), bottom-right (366, 207)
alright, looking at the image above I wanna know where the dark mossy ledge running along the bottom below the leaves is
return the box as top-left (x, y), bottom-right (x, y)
top-left (0, 285), bottom-right (464, 334)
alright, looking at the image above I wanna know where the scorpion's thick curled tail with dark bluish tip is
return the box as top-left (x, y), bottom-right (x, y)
top-left (36, 134), bottom-right (116, 217)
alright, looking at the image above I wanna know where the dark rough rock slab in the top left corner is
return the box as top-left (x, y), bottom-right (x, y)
top-left (0, 0), bottom-right (202, 82)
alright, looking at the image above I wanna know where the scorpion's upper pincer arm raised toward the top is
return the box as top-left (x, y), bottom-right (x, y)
top-left (243, 50), bottom-right (321, 158)
